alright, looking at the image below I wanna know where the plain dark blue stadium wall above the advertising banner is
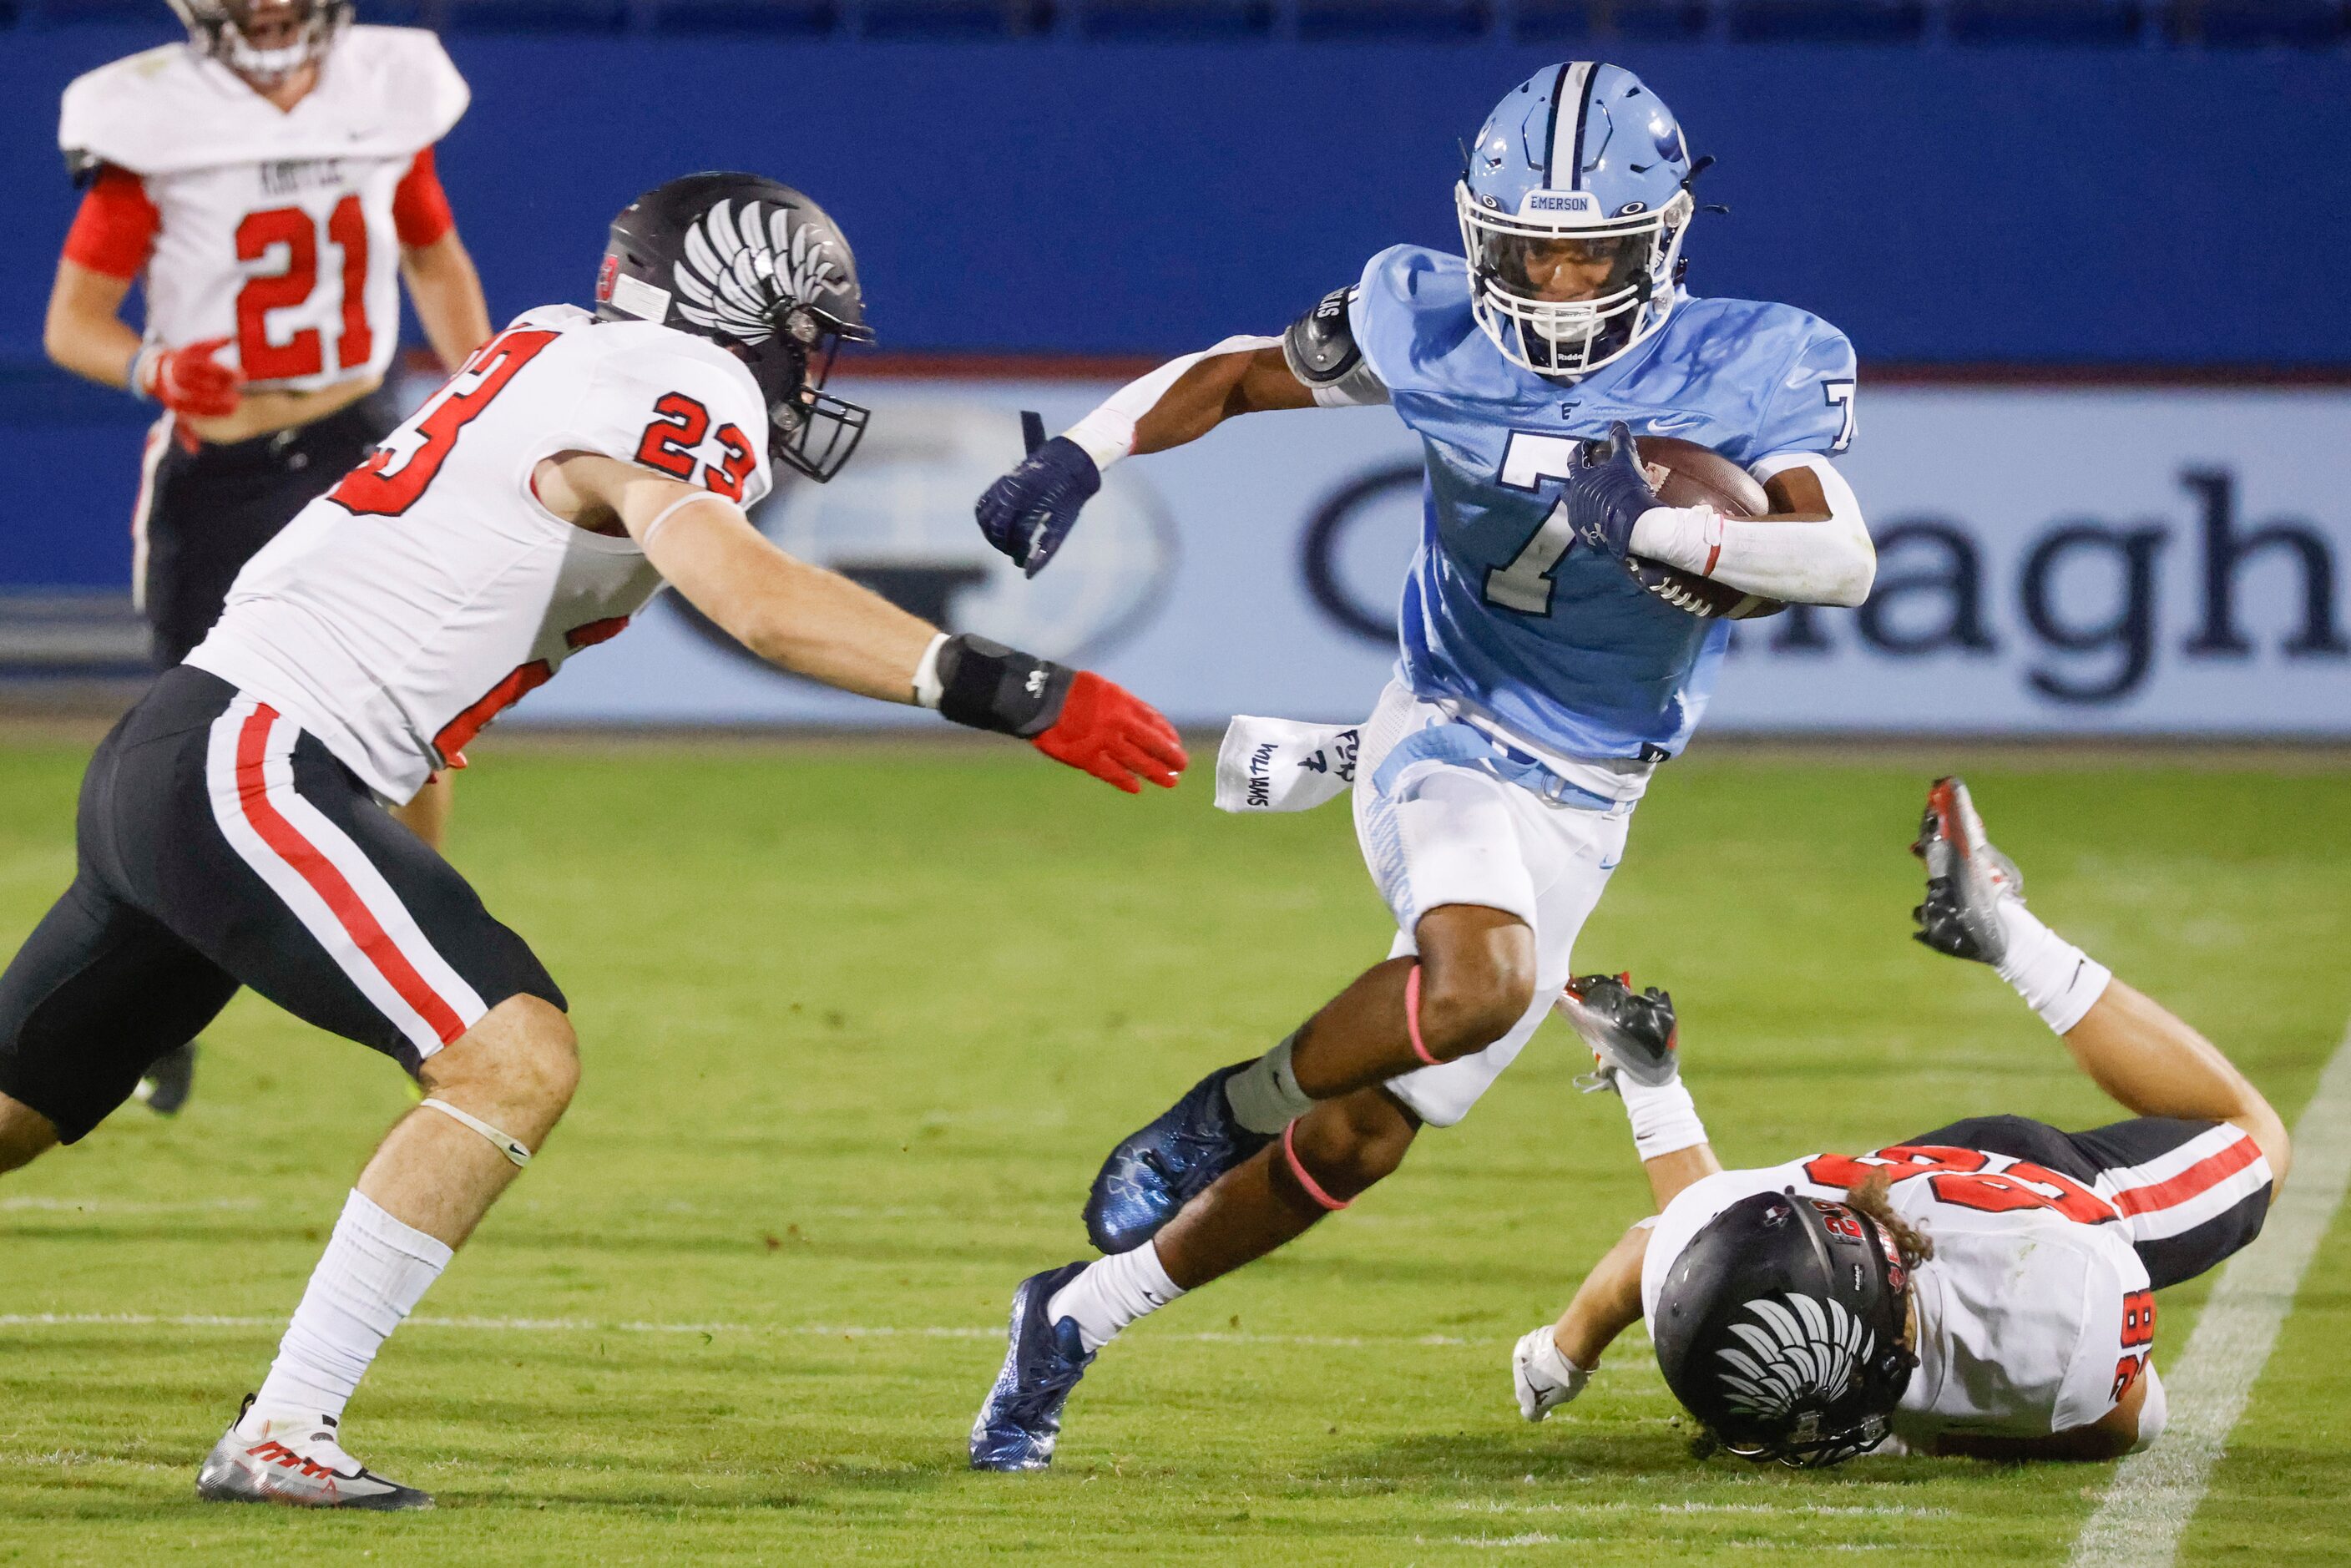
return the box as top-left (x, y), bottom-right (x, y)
top-left (0, 32), bottom-right (2351, 583)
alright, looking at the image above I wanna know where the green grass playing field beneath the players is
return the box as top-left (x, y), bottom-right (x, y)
top-left (0, 743), bottom-right (2351, 1565)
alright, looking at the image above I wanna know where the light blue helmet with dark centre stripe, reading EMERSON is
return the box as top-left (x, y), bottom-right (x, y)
top-left (1453, 61), bottom-right (1691, 378)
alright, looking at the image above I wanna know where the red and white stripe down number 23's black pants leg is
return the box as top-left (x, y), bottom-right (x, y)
top-left (205, 695), bottom-right (489, 1055)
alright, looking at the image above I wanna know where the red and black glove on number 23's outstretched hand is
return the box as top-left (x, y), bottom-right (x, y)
top-left (936, 632), bottom-right (1192, 795)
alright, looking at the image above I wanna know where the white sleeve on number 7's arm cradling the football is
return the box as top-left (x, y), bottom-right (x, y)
top-left (1631, 452), bottom-right (1878, 604)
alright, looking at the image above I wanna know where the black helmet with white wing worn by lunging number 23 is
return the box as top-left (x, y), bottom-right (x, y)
top-left (594, 174), bottom-right (875, 482)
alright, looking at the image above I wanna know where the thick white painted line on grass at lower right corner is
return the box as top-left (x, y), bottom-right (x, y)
top-left (2071, 1032), bottom-right (2351, 1568)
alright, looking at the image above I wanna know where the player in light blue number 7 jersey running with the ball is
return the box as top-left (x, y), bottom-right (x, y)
top-left (971, 61), bottom-right (1876, 1469)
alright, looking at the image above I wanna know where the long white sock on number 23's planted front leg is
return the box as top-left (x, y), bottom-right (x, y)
top-left (247, 1192), bottom-right (449, 1420)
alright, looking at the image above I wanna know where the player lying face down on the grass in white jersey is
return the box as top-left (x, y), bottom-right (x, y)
top-left (1512, 778), bottom-right (2290, 1464)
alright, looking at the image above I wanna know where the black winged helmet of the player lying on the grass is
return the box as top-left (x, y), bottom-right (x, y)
top-left (1651, 1192), bottom-right (1919, 1469)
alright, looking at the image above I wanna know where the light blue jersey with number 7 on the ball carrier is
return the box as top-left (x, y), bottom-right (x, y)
top-left (1347, 245), bottom-right (1853, 757)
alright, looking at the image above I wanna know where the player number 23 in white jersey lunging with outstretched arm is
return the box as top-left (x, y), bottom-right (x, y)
top-left (0, 174), bottom-right (1185, 1510)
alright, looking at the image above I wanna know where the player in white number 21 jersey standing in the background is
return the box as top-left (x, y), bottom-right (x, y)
top-left (43, 0), bottom-right (489, 1115)
